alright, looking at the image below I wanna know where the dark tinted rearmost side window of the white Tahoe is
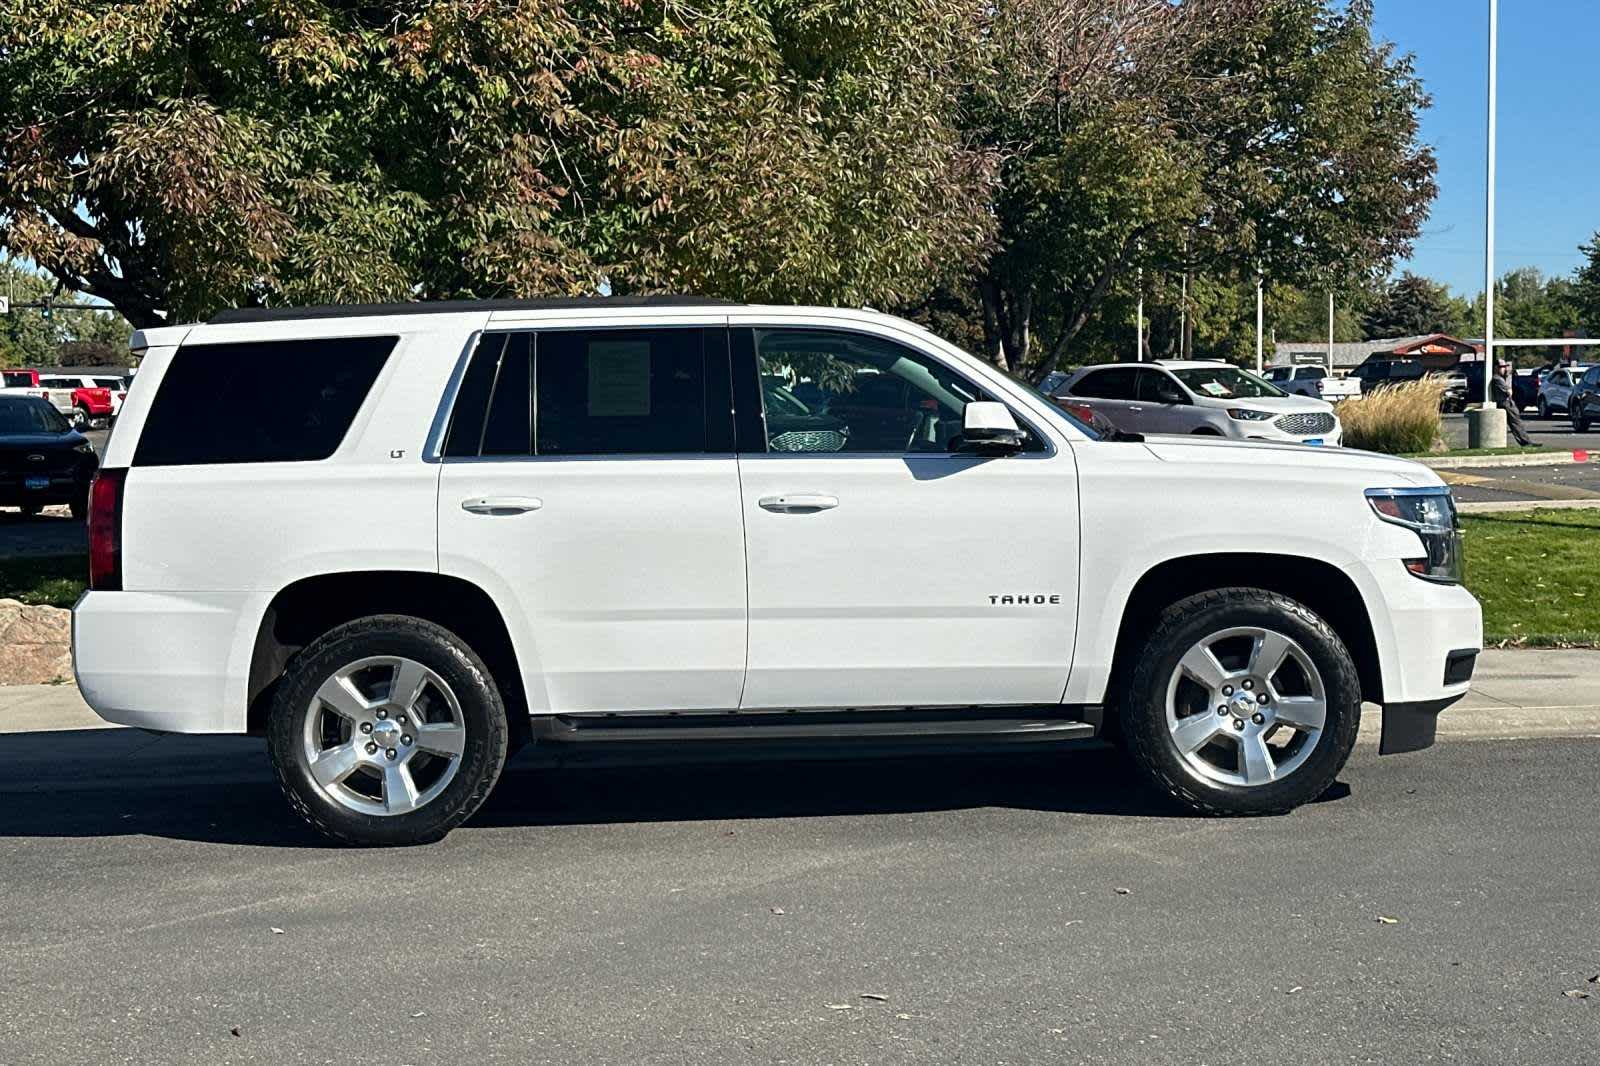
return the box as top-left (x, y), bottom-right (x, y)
top-left (133, 336), bottom-right (398, 466)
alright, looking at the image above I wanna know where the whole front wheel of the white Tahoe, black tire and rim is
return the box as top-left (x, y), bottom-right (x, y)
top-left (1120, 589), bottom-right (1362, 815)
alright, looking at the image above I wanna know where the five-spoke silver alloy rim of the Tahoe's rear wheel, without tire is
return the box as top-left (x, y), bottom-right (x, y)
top-left (302, 655), bottom-right (467, 815)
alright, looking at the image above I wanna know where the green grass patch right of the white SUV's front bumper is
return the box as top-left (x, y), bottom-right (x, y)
top-left (1461, 509), bottom-right (1600, 647)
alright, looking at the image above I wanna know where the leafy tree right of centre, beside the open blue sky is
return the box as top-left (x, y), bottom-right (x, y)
top-left (974, 0), bottom-right (1437, 376)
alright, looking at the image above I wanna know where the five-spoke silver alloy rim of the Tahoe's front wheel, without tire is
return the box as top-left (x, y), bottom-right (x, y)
top-left (1166, 626), bottom-right (1328, 787)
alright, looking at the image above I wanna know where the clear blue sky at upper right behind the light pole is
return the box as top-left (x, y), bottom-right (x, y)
top-left (1374, 0), bottom-right (1600, 295)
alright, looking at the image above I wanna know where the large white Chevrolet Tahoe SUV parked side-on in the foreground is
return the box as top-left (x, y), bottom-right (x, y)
top-left (72, 298), bottom-right (1482, 844)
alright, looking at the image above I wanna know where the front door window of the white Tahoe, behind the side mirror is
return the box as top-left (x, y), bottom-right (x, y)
top-left (755, 330), bottom-right (1043, 453)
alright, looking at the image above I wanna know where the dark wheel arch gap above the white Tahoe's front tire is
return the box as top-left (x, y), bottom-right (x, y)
top-left (1107, 552), bottom-right (1382, 713)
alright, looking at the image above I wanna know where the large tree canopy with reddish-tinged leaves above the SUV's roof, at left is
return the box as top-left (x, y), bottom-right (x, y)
top-left (0, 0), bottom-right (992, 325)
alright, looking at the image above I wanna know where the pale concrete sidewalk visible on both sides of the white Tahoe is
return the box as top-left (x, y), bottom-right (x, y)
top-left (9, 648), bottom-right (1600, 744)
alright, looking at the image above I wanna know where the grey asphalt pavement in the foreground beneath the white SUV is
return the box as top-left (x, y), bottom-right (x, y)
top-left (0, 717), bottom-right (1600, 1063)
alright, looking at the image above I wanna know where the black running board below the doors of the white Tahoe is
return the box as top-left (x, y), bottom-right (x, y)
top-left (533, 706), bottom-right (1096, 744)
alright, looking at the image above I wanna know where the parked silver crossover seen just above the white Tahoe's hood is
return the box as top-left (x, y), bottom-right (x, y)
top-left (1054, 360), bottom-right (1344, 447)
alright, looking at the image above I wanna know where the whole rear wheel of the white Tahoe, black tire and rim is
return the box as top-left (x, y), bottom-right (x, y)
top-left (267, 615), bottom-right (509, 845)
